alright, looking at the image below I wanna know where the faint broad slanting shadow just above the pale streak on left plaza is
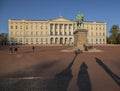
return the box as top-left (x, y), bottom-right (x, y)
top-left (1, 60), bottom-right (60, 78)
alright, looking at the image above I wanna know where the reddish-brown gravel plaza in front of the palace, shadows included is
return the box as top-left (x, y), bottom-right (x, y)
top-left (0, 45), bottom-right (120, 91)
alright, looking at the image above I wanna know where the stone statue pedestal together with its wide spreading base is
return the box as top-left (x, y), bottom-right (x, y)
top-left (61, 29), bottom-right (103, 52)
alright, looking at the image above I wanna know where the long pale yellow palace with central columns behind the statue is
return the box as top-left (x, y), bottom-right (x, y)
top-left (8, 17), bottom-right (106, 45)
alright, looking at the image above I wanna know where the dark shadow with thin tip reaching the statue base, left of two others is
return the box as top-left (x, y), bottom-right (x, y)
top-left (49, 54), bottom-right (78, 91)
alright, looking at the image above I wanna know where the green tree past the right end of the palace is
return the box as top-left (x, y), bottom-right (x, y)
top-left (108, 25), bottom-right (119, 44)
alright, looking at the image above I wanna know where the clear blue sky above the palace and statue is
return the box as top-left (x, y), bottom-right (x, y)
top-left (0, 0), bottom-right (120, 36)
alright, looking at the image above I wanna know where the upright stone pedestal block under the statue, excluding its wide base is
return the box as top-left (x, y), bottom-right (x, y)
top-left (74, 29), bottom-right (88, 51)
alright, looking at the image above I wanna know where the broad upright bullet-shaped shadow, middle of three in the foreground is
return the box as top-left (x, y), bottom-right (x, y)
top-left (77, 62), bottom-right (92, 91)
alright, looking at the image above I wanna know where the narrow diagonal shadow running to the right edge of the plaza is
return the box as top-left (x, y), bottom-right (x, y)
top-left (96, 57), bottom-right (120, 86)
